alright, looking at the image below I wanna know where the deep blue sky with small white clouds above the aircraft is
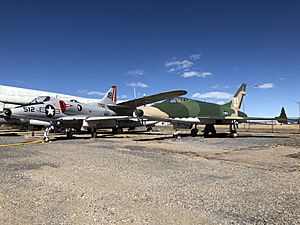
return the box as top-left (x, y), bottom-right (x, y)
top-left (0, 0), bottom-right (300, 116)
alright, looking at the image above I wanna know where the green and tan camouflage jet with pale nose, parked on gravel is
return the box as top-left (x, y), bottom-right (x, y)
top-left (133, 83), bottom-right (278, 137)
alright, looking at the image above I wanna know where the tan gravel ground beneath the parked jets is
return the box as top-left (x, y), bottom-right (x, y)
top-left (0, 132), bottom-right (300, 225)
